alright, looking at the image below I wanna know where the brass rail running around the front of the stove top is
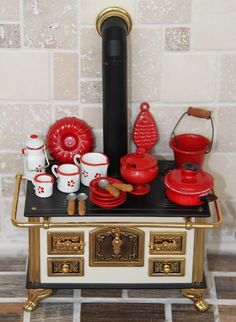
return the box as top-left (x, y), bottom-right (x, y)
top-left (11, 174), bottom-right (222, 230)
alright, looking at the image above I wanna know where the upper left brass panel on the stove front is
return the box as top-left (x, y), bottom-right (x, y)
top-left (47, 232), bottom-right (84, 255)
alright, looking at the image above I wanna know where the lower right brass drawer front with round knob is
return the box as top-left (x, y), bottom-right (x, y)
top-left (149, 258), bottom-right (185, 276)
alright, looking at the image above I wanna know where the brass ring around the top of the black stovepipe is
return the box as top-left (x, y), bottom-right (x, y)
top-left (96, 7), bottom-right (132, 36)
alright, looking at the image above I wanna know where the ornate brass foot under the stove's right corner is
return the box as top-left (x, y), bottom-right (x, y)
top-left (181, 288), bottom-right (209, 312)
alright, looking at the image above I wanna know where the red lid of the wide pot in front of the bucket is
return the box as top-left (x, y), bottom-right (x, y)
top-left (164, 162), bottom-right (213, 195)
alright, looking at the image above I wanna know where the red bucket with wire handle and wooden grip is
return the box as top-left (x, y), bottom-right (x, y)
top-left (169, 107), bottom-right (214, 168)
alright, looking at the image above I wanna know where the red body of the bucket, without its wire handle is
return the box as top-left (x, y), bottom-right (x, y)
top-left (169, 134), bottom-right (211, 168)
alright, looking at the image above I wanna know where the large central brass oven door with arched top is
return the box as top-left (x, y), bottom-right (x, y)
top-left (89, 227), bottom-right (144, 267)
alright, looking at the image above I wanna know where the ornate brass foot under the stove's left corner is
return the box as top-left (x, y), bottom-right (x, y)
top-left (24, 288), bottom-right (53, 312)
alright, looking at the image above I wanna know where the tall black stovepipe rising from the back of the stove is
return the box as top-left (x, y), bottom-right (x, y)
top-left (98, 10), bottom-right (131, 177)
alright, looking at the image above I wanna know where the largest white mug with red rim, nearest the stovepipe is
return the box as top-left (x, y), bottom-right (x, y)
top-left (74, 152), bottom-right (109, 186)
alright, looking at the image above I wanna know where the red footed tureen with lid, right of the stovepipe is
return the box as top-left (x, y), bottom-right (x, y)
top-left (120, 148), bottom-right (158, 195)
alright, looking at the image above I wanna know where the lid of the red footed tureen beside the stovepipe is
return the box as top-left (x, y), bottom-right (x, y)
top-left (120, 149), bottom-right (157, 170)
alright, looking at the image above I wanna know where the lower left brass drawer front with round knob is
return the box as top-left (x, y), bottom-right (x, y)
top-left (48, 257), bottom-right (84, 276)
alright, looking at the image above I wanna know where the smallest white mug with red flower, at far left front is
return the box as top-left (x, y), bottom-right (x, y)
top-left (32, 173), bottom-right (54, 198)
